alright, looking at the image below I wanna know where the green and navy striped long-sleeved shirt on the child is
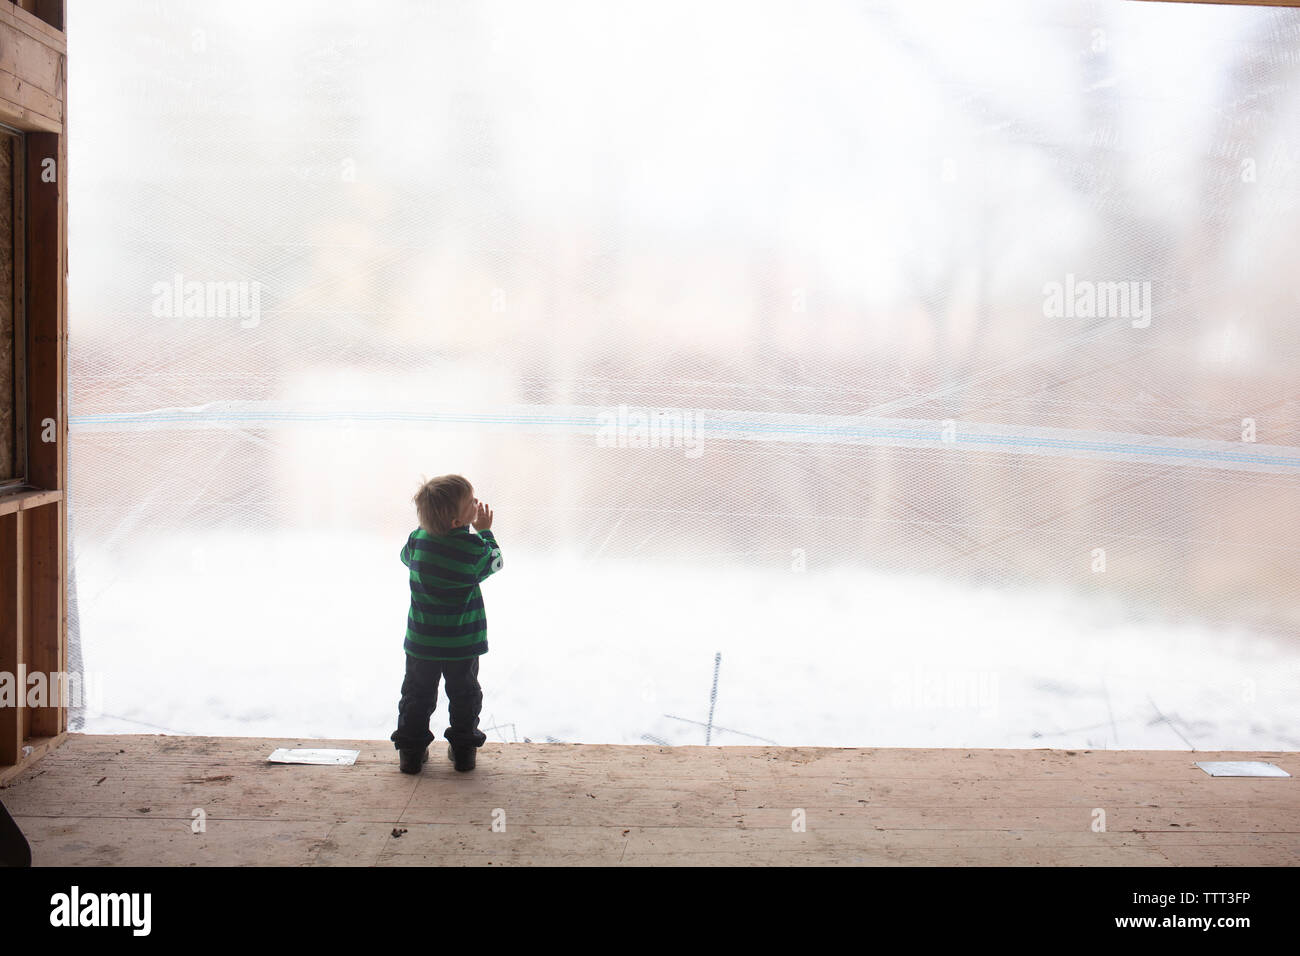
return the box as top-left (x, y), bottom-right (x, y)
top-left (402, 524), bottom-right (501, 661)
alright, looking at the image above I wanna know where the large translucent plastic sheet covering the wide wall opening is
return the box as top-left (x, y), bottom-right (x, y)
top-left (68, 0), bottom-right (1300, 749)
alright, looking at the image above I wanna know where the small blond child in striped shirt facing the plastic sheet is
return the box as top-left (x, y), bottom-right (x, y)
top-left (391, 475), bottom-right (502, 774)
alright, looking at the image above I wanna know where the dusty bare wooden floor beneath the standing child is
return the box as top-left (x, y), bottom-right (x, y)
top-left (0, 734), bottom-right (1300, 866)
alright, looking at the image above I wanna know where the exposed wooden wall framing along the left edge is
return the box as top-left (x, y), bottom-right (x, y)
top-left (0, 0), bottom-right (68, 778)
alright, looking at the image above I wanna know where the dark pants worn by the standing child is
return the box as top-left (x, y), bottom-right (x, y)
top-left (390, 654), bottom-right (488, 750)
